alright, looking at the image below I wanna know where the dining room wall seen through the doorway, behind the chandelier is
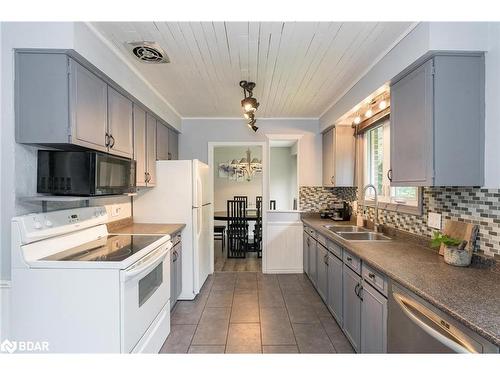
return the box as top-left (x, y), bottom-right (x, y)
top-left (214, 146), bottom-right (262, 211)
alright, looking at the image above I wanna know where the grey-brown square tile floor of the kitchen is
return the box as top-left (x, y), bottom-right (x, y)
top-left (161, 272), bottom-right (353, 353)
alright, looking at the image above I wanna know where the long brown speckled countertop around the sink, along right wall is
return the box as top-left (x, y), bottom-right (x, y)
top-left (302, 216), bottom-right (500, 346)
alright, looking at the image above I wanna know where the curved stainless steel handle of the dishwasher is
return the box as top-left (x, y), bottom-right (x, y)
top-left (393, 293), bottom-right (476, 353)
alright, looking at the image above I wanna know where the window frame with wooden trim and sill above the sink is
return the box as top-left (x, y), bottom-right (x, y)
top-left (358, 116), bottom-right (423, 215)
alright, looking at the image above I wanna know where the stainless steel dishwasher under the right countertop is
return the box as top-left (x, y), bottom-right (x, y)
top-left (387, 282), bottom-right (498, 353)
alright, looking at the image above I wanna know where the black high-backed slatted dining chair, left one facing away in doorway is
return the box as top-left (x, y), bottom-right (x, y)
top-left (227, 200), bottom-right (248, 258)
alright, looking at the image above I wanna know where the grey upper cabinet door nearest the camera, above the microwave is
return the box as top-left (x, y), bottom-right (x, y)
top-left (70, 59), bottom-right (108, 152)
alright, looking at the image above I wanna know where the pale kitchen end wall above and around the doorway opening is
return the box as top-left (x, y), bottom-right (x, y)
top-left (179, 118), bottom-right (321, 186)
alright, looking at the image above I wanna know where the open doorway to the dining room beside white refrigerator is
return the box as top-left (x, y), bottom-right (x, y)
top-left (208, 142), bottom-right (267, 272)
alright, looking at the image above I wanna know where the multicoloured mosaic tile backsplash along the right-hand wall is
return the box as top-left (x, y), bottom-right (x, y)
top-left (300, 186), bottom-right (500, 259)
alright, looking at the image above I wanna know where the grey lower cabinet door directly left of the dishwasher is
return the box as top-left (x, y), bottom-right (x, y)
top-left (360, 283), bottom-right (387, 353)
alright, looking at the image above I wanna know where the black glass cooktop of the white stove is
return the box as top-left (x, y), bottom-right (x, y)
top-left (41, 235), bottom-right (163, 262)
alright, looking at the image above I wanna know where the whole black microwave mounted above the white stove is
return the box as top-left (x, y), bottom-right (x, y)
top-left (37, 150), bottom-right (136, 196)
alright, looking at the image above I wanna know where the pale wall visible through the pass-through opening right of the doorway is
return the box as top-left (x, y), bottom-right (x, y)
top-left (269, 147), bottom-right (298, 210)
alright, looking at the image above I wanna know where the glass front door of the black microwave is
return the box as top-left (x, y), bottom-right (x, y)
top-left (93, 153), bottom-right (136, 195)
